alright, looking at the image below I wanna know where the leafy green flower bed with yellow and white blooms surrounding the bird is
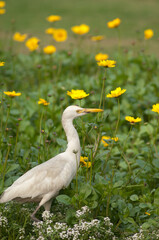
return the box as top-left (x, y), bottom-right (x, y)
top-left (0, 0), bottom-right (159, 240)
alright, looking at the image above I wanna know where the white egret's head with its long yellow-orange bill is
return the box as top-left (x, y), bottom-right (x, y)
top-left (63, 105), bottom-right (103, 119)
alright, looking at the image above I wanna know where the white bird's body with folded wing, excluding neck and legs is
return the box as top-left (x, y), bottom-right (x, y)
top-left (0, 153), bottom-right (75, 202)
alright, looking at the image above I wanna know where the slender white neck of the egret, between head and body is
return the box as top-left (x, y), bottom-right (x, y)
top-left (62, 119), bottom-right (81, 162)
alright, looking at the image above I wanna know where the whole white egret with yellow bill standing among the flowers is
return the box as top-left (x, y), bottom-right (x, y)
top-left (0, 106), bottom-right (103, 221)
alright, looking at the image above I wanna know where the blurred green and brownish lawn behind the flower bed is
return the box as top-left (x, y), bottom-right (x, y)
top-left (1, 0), bottom-right (159, 53)
